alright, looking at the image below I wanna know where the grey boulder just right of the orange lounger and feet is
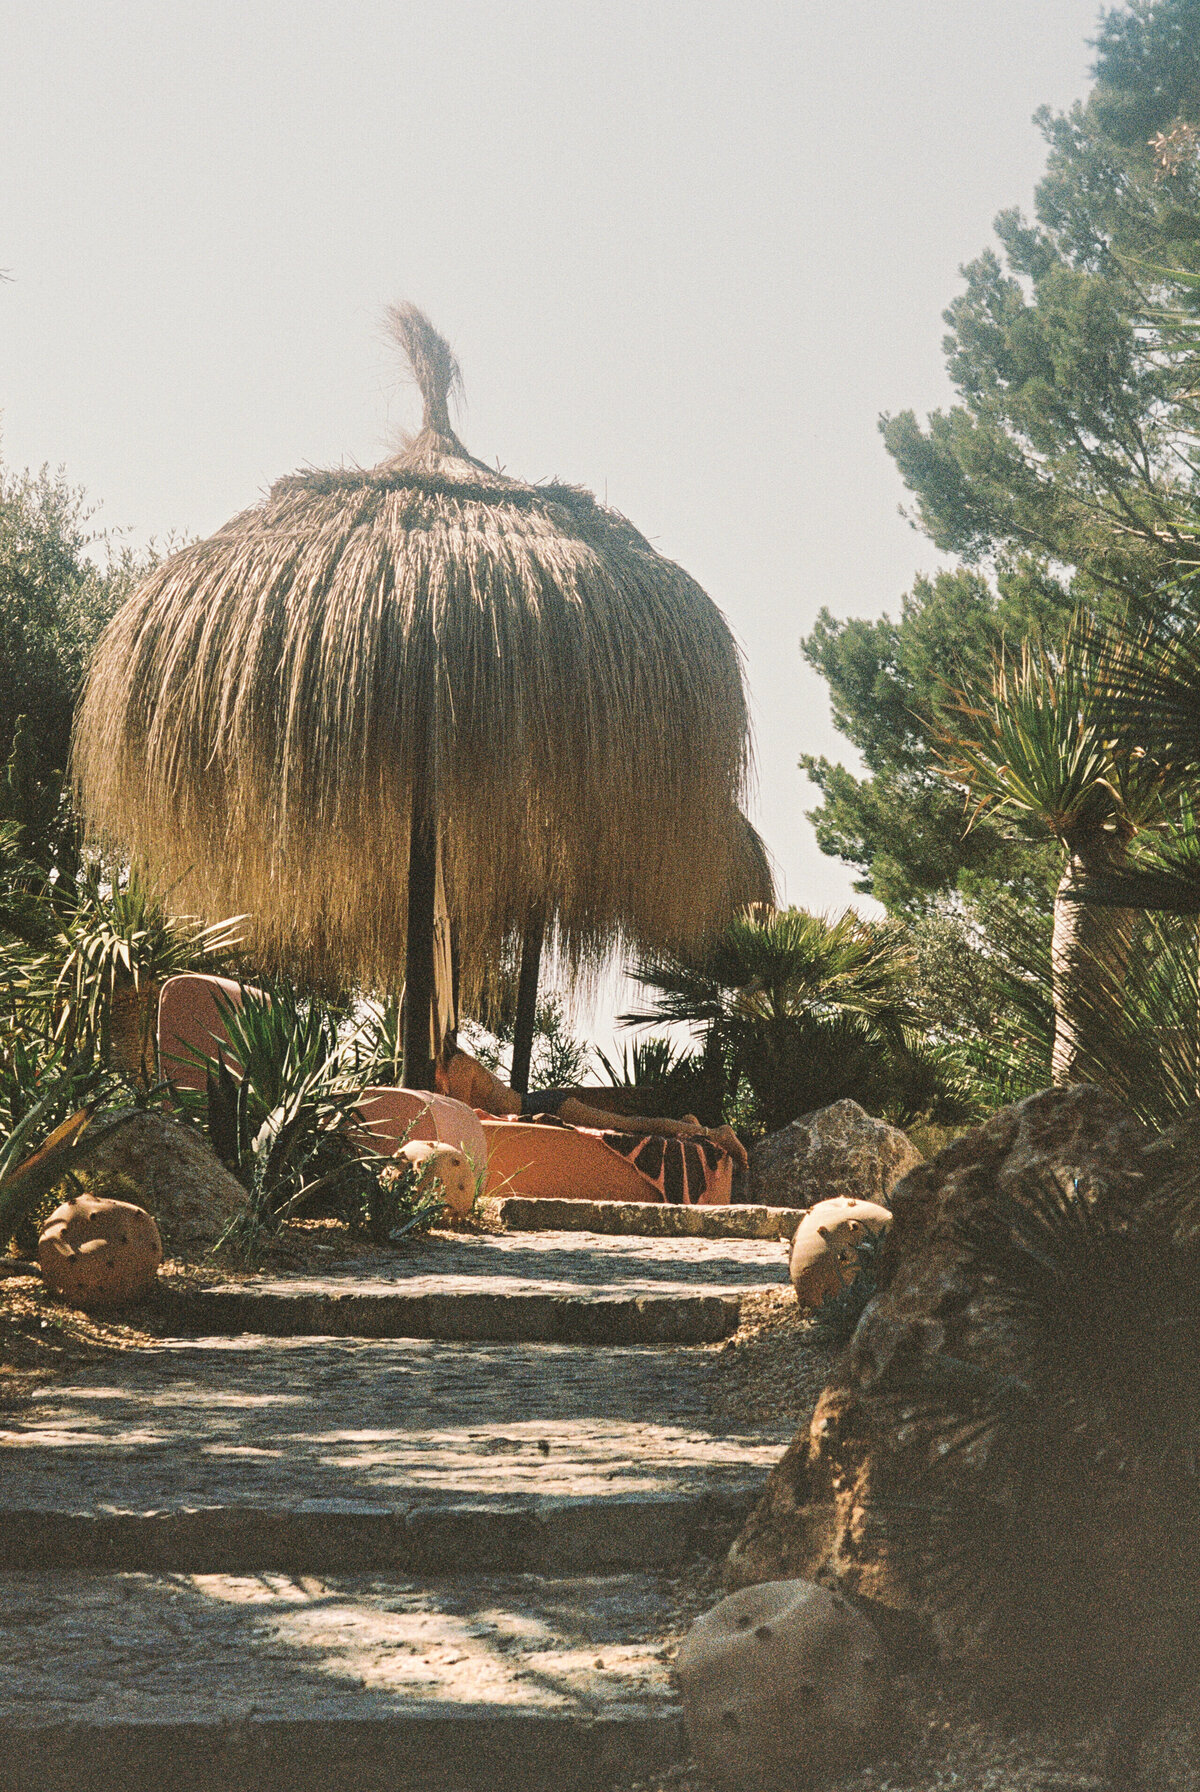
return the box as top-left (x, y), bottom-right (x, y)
top-left (741, 1100), bottom-right (922, 1208)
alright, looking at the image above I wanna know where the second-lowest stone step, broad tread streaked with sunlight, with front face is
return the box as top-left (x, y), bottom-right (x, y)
top-left (0, 1337), bottom-right (795, 1572)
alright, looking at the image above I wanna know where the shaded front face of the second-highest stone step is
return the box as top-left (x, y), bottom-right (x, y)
top-left (156, 1285), bottom-right (740, 1344)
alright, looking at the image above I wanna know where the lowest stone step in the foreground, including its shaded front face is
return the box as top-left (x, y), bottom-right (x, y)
top-left (0, 1572), bottom-right (690, 1792)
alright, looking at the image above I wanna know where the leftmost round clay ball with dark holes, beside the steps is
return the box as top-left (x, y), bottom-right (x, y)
top-left (38, 1195), bottom-right (163, 1306)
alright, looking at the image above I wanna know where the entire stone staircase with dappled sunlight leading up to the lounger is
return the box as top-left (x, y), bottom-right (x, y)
top-left (0, 1201), bottom-right (809, 1792)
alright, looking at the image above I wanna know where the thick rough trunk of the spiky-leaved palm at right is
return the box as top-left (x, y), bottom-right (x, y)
top-left (1050, 846), bottom-right (1136, 1088)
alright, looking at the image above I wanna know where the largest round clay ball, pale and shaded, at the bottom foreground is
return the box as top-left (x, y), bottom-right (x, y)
top-left (675, 1581), bottom-right (888, 1792)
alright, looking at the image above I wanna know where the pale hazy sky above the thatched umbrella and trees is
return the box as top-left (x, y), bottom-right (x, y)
top-left (0, 0), bottom-right (1100, 1039)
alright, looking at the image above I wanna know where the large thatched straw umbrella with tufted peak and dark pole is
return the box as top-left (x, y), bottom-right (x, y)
top-left (73, 306), bottom-right (762, 1086)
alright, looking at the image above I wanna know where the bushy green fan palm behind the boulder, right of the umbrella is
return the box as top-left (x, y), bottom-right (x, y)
top-left (621, 907), bottom-right (915, 1131)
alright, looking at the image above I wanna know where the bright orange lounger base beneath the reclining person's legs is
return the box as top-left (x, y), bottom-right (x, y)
top-left (484, 1118), bottom-right (733, 1206)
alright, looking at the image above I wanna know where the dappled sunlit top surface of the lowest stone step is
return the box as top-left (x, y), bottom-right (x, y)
top-left (0, 1573), bottom-right (677, 1726)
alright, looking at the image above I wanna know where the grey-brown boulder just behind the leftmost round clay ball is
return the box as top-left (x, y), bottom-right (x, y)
top-left (80, 1111), bottom-right (247, 1251)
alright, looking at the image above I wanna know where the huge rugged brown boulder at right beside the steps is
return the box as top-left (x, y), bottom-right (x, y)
top-left (727, 1086), bottom-right (1174, 1686)
